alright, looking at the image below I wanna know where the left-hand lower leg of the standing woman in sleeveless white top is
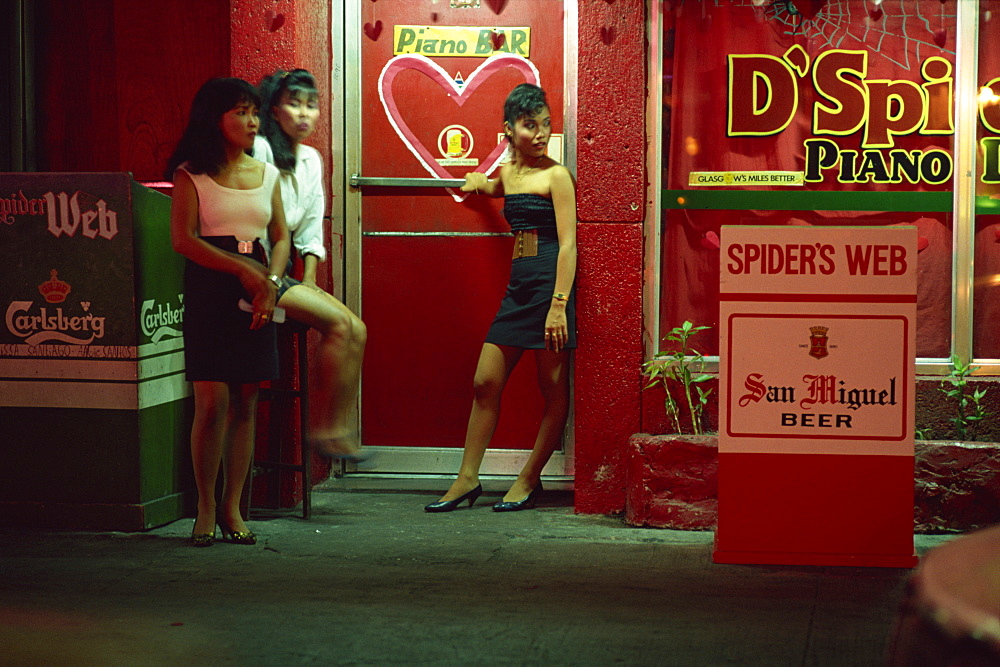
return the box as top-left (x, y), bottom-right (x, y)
top-left (191, 382), bottom-right (229, 535)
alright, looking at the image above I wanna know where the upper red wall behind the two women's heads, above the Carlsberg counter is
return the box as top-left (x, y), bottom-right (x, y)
top-left (33, 0), bottom-right (330, 190)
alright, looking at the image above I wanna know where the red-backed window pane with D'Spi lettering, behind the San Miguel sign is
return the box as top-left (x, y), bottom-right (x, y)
top-left (660, 0), bottom-right (956, 357)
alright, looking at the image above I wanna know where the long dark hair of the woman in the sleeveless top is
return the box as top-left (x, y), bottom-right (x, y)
top-left (164, 78), bottom-right (260, 180)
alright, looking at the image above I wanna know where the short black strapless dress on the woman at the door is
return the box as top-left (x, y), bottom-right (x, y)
top-left (486, 193), bottom-right (576, 350)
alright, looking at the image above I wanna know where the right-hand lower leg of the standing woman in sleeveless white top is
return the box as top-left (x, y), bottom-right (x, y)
top-left (219, 384), bottom-right (259, 532)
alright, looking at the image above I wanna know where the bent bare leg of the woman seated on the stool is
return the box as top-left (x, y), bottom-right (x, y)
top-left (278, 285), bottom-right (368, 451)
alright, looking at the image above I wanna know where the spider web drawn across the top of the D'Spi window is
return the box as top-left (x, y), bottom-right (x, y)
top-left (675, 0), bottom-right (956, 71)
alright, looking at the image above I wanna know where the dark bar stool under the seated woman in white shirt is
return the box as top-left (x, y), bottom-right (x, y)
top-left (253, 320), bottom-right (312, 519)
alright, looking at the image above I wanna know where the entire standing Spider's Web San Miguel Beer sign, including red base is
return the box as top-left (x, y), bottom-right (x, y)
top-left (715, 226), bottom-right (917, 567)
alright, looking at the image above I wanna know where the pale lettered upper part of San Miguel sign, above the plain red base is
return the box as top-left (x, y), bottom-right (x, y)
top-left (719, 226), bottom-right (916, 456)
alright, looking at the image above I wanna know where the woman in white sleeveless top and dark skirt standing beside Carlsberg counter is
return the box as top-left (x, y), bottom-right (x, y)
top-left (167, 79), bottom-right (289, 547)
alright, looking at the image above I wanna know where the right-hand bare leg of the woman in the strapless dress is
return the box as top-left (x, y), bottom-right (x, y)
top-left (503, 350), bottom-right (569, 502)
